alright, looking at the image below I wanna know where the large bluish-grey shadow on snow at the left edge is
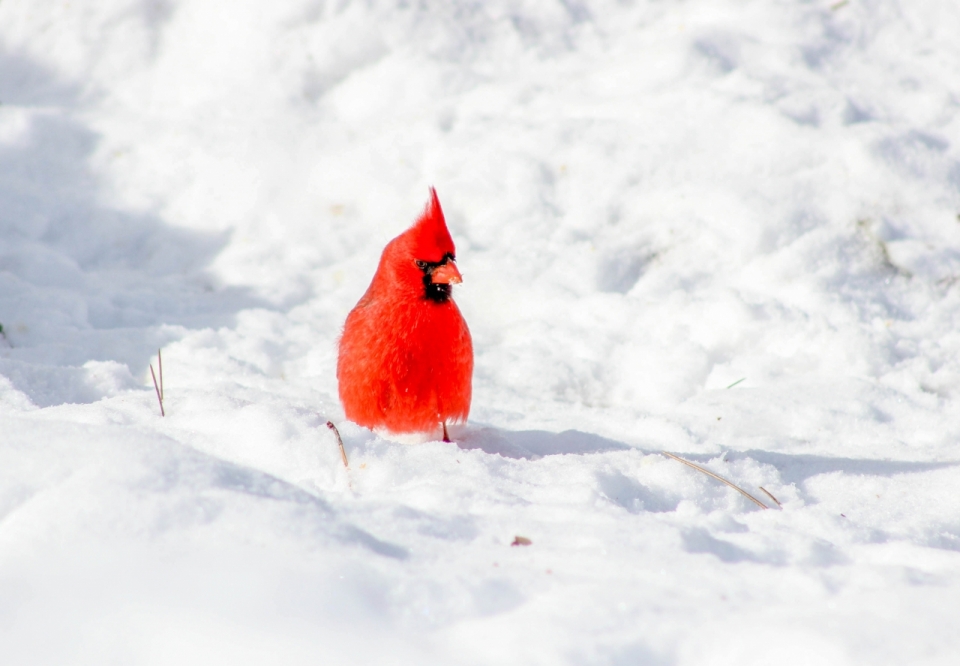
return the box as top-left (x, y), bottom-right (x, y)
top-left (0, 44), bottom-right (270, 407)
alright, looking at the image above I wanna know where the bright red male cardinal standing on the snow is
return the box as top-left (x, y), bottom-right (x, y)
top-left (337, 188), bottom-right (473, 441)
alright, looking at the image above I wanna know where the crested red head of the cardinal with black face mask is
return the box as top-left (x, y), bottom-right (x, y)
top-left (381, 187), bottom-right (463, 303)
